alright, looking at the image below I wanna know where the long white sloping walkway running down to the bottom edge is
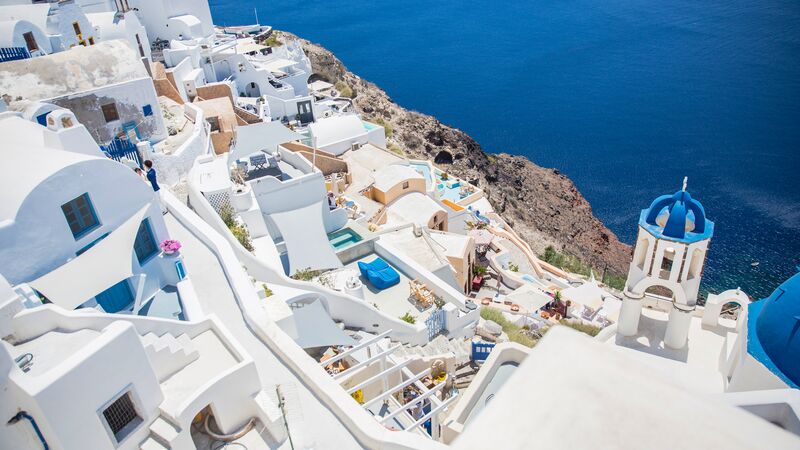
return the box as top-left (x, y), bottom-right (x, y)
top-left (165, 214), bottom-right (361, 450)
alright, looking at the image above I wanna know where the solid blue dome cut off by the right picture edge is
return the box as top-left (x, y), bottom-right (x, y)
top-left (747, 273), bottom-right (800, 388)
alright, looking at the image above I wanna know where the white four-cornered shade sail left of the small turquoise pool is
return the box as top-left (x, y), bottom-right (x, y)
top-left (269, 200), bottom-right (342, 274)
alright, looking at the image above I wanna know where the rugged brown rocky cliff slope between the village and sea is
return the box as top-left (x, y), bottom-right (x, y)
top-left (281, 33), bottom-right (631, 275)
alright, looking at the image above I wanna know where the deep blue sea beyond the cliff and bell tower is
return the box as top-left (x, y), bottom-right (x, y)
top-left (211, 0), bottom-right (800, 298)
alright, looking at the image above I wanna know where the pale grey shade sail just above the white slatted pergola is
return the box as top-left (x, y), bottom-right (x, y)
top-left (278, 301), bottom-right (356, 348)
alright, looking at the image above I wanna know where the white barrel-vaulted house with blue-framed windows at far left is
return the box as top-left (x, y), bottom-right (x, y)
top-left (0, 110), bottom-right (183, 314)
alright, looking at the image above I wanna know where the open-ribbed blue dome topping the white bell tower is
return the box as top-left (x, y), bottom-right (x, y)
top-left (639, 190), bottom-right (714, 243)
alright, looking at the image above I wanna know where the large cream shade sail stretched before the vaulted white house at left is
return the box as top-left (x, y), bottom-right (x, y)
top-left (28, 203), bottom-right (150, 310)
